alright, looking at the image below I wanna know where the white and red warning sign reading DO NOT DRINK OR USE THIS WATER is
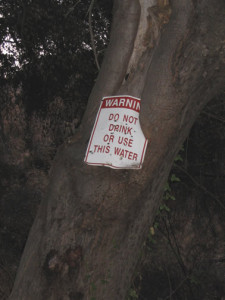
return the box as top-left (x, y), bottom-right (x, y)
top-left (84, 95), bottom-right (148, 169)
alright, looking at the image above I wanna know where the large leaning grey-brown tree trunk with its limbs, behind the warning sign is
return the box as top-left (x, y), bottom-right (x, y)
top-left (9, 0), bottom-right (225, 300)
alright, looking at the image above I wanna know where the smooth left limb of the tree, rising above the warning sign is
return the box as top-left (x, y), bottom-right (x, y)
top-left (82, 0), bottom-right (140, 138)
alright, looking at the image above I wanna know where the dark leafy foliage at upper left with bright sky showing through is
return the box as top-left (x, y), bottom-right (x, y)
top-left (0, 0), bottom-right (112, 112)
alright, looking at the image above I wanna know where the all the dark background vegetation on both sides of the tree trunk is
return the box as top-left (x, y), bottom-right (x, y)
top-left (0, 0), bottom-right (225, 300)
